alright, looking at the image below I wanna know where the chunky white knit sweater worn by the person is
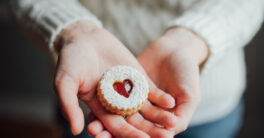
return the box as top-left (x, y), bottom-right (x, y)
top-left (12, 0), bottom-right (264, 125)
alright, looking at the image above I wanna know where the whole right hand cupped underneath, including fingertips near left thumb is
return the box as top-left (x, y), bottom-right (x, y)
top-left (88, 28), bottom-right (208, 138)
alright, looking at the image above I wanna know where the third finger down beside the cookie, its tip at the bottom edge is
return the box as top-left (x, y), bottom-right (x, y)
top-left (127, 113), bottom-right (173, 138)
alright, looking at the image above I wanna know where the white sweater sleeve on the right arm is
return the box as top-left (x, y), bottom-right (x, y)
top-left (168, 0), bottom-right (264, 73)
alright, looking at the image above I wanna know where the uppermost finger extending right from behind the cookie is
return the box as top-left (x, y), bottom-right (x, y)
top-left (148, 80), bottom-right (175, 108)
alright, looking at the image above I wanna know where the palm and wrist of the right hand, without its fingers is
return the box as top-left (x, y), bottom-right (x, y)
top-left (135, 27), bottom-right (208, 135)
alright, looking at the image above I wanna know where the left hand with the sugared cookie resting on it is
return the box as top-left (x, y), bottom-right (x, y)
top-left (54, 21), bottom-right (175, 137)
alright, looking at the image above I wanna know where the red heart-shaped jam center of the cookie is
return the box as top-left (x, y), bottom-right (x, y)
top-left (113, 79), bottom-right (133, 98)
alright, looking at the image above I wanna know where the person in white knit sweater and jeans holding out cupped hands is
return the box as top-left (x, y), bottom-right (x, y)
top-left (11, 0), bottom-right (264, 138)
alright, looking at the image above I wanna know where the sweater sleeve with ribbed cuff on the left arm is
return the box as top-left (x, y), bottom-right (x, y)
top-left (11, 0), bottom-right (102, 51)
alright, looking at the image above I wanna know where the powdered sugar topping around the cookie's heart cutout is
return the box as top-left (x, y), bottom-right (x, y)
top-left (98, 66), bottom-right (149, 110)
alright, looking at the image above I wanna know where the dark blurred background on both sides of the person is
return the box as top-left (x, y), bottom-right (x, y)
top-left (0, 0), bottom-right (264, 138)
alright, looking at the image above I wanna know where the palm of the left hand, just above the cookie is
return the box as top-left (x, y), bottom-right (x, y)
top-left (57, 29), bottom-right (142, 102)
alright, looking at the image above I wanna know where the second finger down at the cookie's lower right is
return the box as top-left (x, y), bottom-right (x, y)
top-left (140, 101), bottom-right (177, 128)
